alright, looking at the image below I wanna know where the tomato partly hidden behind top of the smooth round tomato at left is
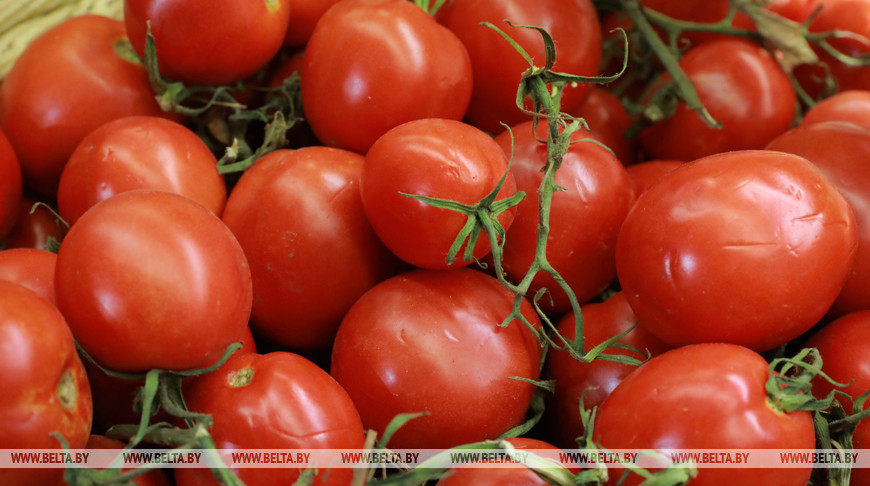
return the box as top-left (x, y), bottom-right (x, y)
top-left (57, 116), bottom-right (227, 224)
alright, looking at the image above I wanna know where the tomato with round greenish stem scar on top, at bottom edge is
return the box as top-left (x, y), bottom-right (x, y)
top-left (175, 351), bottom-right (365, 486)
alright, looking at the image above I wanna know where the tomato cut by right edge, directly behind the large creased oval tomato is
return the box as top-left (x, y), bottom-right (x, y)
top-left (768, 122), bottom-right (870, 316)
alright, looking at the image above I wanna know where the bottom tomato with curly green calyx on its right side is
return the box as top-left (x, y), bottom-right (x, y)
top-left (594, 343), bottom-right (815, 486)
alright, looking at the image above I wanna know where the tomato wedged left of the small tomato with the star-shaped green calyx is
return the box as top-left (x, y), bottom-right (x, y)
top-left (223, 147), bottom-right (400, 349)
